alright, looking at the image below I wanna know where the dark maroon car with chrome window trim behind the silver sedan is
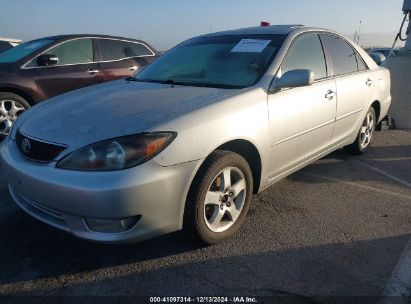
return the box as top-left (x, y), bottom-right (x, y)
top-left (0, 35), bottom-right (159, 136)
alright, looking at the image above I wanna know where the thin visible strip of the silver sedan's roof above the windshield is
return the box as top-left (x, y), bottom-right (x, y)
top-left (202, 24), bottom-right (305, 37)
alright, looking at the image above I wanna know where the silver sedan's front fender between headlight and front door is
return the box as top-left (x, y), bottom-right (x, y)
top-left (150, 88), bottom-right (270, 185)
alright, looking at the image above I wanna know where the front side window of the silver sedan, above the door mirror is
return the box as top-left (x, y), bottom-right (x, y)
top-left (281, 34), bottom-right (327, 79)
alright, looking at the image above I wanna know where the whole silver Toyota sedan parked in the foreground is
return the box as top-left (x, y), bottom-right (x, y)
top-left (0, 26), bottom-right (391, 244)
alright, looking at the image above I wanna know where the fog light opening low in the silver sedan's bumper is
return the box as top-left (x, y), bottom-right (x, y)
top-left (85, 215), bottom-right (141, 233)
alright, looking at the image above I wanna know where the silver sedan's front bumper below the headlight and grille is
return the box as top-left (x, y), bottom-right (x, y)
top-left (0, 138), bottom-right (197, 243)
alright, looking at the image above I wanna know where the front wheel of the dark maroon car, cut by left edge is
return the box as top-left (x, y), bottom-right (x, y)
top-left (0, 92), bottom-right (30, 138)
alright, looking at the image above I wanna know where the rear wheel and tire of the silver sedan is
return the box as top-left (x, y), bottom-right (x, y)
top-left (345, 107), bottom-right (377, 155)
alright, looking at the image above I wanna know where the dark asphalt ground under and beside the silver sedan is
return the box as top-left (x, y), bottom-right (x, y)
top-left (0, 131), bottom-right (411, 303)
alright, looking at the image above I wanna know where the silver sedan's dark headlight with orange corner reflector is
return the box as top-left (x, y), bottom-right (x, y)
top-left (57, 132), bottom-right (176, 171)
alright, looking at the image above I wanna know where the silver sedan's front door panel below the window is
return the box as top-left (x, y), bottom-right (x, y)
top-left (268, 79), bottom-right (337, 179)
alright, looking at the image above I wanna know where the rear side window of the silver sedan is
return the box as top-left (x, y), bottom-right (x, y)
top-left (321, 34), bottom-right (359, 76)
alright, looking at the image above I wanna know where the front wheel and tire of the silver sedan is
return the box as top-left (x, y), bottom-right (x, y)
top-left (184, 151), bottom-right (253, 245)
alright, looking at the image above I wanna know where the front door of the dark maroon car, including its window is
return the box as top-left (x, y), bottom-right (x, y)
top-left (31, 38), bottom-right (100, 98)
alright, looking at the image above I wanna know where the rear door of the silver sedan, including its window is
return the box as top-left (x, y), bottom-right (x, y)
top-left (321, 34), bottom-right (375, 142)
